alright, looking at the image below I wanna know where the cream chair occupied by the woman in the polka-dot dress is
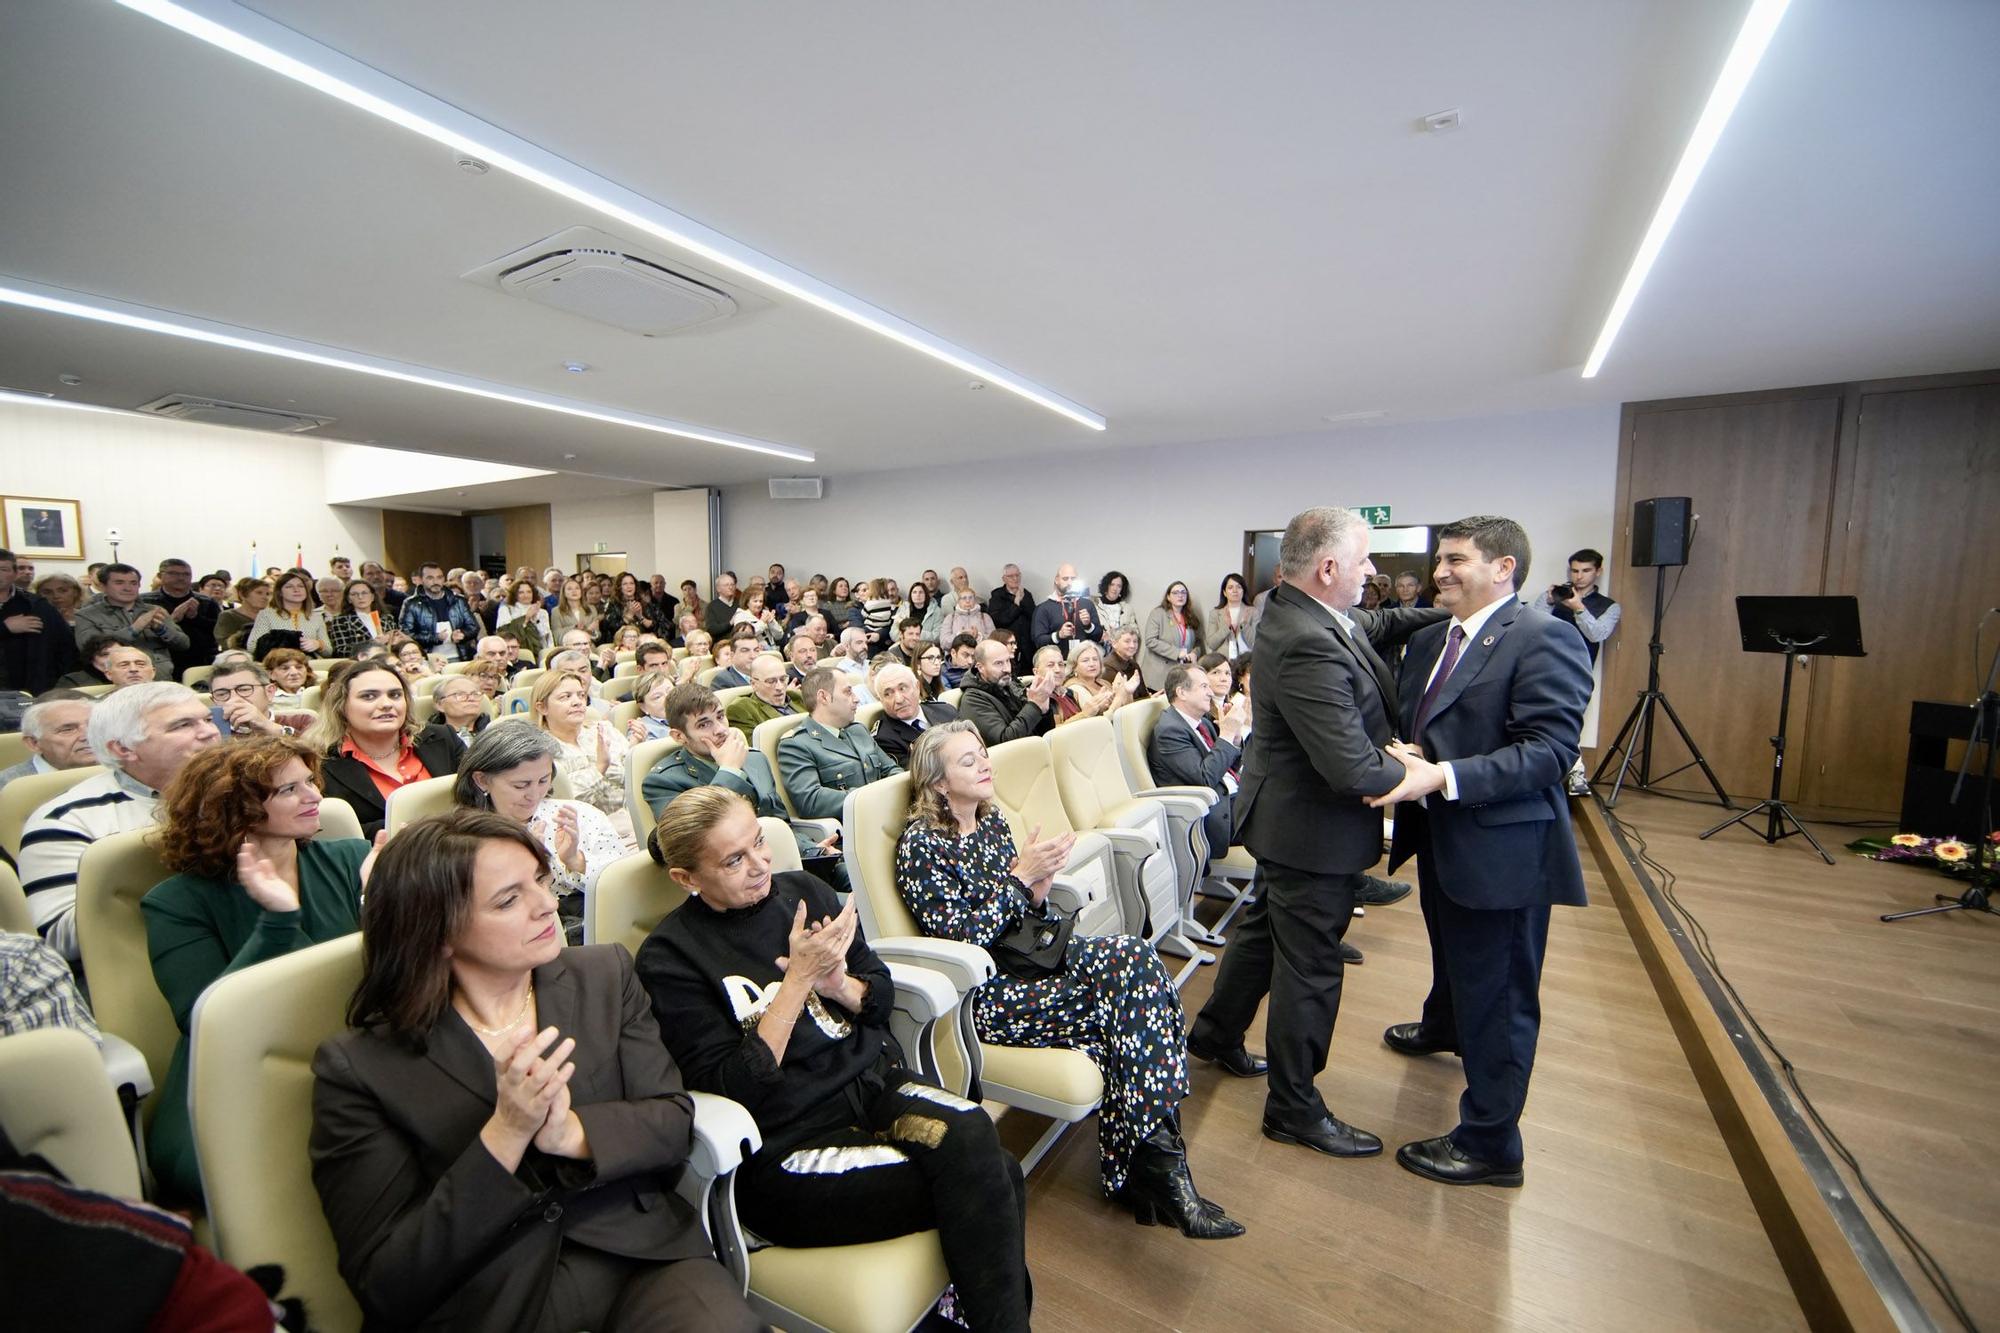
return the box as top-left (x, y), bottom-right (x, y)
top-left (840, 773), bottom-right (1104, 1171)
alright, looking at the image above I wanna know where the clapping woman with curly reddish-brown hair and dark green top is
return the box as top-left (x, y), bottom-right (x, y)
top-left (140, 737), bottom-right (370, 1203)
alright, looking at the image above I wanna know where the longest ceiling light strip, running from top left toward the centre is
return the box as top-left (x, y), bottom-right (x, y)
top-left (118, 0), bottom-right (1104, 430)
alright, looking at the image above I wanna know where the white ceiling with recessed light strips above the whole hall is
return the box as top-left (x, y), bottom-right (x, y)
top-left (0, 0), bottom-right (2000, 484)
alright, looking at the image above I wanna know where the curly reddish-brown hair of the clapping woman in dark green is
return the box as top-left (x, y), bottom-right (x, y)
top-left (154, 737), bottom-right (320, 879)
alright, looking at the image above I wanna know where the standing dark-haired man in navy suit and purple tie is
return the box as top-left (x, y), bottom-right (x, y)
top-left (1368, 518), bottom-right (1590, 1185)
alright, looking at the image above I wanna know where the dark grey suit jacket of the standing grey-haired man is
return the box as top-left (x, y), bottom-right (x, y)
top-left (1236, 584), bottom-right (1444, 875)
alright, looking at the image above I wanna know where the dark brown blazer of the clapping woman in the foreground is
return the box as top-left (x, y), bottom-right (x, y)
top-left (298, 945), bottom-right (714, 1331)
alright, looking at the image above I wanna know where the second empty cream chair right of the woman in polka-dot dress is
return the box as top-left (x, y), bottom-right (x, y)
top-left (1048, 717), bottom-right (1214, 985)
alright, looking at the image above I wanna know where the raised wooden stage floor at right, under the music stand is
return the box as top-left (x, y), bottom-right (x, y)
top-left (1608, 795), bottom-right (2000, 1329)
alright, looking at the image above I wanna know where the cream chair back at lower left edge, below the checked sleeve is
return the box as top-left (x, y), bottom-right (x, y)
top-left (0, 1027), bottom-right (140, 1199)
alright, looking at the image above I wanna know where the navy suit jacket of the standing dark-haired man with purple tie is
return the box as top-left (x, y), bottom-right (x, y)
top-left (1392, 600), bottom-right (1592, 909)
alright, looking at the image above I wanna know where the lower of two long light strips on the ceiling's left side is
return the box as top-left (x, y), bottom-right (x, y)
top-left (0, 276), bottom-right (814, 462)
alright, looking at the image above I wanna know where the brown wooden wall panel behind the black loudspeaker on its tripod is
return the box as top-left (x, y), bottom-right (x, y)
top-left (1598, 390), bottom-right (1840, 797)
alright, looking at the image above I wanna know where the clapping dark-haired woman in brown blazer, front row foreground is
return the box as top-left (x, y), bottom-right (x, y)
top-left (310, 811), bottom-right (762, 1333)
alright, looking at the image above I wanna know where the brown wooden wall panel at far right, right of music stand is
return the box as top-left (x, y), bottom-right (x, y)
top-left (1798, 382), bottom-right (2000, 804)
